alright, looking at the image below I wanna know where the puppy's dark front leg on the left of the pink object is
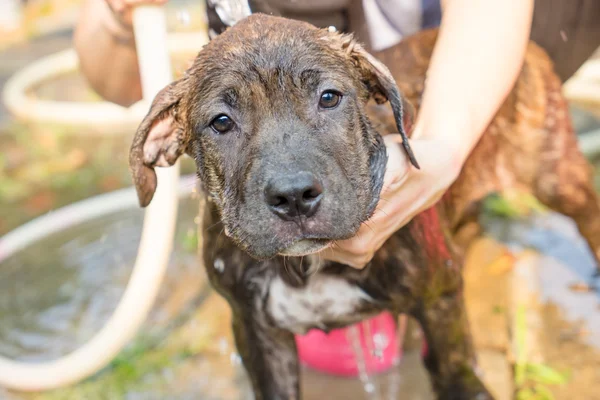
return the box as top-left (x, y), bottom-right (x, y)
top-left (233, 310), bottom-right (300, 400)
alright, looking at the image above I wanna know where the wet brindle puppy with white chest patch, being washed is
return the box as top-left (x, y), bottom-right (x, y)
top-left (130, 15), bottom-right (600, 400)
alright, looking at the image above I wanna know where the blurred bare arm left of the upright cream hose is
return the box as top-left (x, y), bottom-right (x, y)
top-left (74, 0), bottom-right (142, 106)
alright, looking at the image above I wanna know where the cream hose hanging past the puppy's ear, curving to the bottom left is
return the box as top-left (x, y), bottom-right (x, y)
top-left (0, 6), bottom-right (179, 391)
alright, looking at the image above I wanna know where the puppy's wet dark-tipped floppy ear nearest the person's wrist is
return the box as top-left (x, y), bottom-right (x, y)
top-left (338, 35), bottom-right (419, 168)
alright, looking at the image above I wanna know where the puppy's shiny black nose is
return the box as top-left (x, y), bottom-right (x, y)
top-left (265, 172), bottom-right (323, 220)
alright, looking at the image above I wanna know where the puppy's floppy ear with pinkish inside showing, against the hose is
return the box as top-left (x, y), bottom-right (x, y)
top-left (129, 78), bottom-right (188, 207)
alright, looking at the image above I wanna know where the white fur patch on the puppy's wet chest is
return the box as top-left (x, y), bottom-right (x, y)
top-left (267, 273), bottom-right (371, 334)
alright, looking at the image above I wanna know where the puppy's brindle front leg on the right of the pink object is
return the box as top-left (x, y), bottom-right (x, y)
top-left (412, 290), bottom-right (493, 400)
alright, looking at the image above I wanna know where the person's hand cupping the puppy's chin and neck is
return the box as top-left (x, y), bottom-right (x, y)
top-left (321, 134), bottom-right (464, 269)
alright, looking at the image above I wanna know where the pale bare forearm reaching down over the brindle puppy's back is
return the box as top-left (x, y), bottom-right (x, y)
top-left (413, 0), bottom-right (533, 166)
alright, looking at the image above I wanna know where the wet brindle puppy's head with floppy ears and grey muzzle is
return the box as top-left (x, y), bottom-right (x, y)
top-left (130, 14), bottom-right (416, 259)
